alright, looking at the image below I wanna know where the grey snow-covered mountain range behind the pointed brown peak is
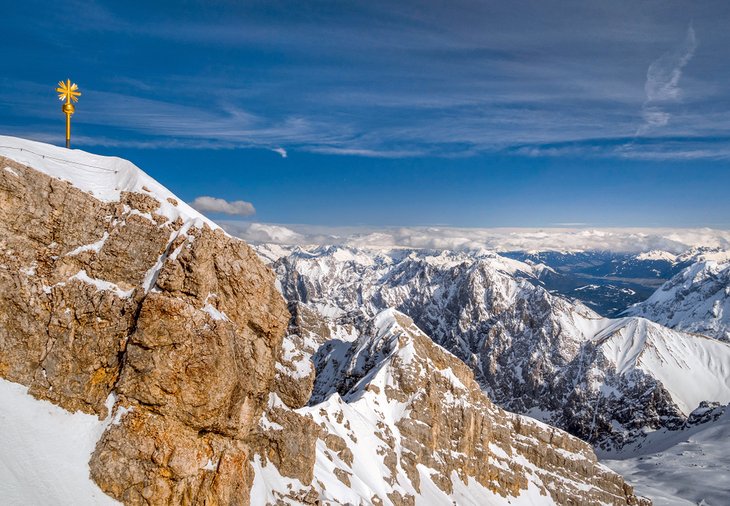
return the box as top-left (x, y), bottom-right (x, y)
top-left (258, 246), bottom-right (730, 450)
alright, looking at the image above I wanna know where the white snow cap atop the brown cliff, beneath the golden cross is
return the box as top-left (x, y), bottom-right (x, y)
top-left (0, 135), bottom-right (220, 229)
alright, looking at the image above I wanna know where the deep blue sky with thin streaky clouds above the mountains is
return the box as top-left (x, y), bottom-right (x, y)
top-left (0, 0), bottom-right (730, 228)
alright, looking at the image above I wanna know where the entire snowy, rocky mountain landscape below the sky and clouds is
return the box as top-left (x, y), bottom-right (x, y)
top-left (0, 137), bottom-right (730, 505)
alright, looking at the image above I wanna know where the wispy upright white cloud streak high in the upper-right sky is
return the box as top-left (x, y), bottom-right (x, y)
top-left (637, 23), bottom-right (697, 135)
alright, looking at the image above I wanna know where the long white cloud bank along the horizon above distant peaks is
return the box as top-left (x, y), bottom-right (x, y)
top-left (220, 221), bottom-right (730, 254)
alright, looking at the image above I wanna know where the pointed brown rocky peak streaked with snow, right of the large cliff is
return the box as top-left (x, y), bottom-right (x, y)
top-left (255, 310), bottom-right (649, 505)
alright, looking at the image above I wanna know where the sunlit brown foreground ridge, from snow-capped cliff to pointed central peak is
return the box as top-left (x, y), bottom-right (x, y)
top-left (0, 138), bottom-right (646, 505)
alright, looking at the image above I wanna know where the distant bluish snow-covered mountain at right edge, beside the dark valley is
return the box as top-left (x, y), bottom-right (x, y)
top-left (626, 253), bottom-right (730, 341)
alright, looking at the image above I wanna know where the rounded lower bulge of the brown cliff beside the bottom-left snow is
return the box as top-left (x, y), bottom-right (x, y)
top-left (91, 406), bottom-right (253, 504)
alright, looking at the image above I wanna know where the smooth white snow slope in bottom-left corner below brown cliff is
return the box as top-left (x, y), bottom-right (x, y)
top-left (0, 379), bottom-right (119, 506)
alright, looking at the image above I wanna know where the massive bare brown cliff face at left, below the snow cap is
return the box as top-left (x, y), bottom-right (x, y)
top-left (0, 157), bottom-right (289, 504)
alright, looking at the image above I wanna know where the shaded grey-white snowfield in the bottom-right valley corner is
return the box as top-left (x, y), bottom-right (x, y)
top-left (602, 409), bottom-right (730, 506)
